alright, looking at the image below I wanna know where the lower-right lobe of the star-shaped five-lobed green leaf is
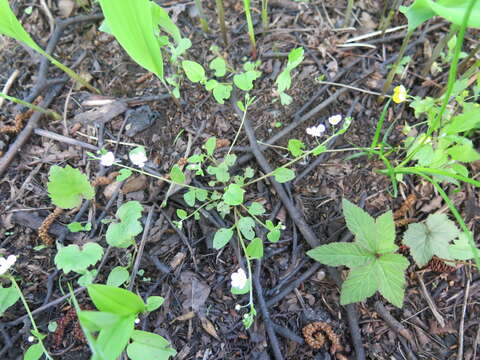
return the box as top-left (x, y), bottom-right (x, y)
top-left (375, 254), bottom-right (409, 308)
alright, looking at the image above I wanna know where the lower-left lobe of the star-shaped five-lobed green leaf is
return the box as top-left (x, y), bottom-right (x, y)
top-left (340, 262), bottom-right (377, 305)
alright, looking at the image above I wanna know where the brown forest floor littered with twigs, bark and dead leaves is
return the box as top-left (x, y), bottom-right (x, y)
top-left (0, 0), bottom-right (480, 360)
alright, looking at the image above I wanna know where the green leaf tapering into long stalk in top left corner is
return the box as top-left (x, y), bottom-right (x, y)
top-left (0, 0), bottom-right (99, 93)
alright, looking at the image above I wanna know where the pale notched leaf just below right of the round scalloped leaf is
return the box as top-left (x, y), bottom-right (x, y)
top-left (106, 201), bottom-right (143, 248)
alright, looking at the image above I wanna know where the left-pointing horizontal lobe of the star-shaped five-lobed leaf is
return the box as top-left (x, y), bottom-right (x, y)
top-left (307, 242), bottom-right (375, 267)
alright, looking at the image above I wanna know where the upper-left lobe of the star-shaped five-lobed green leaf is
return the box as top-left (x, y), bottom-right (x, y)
top-left (342, 199), bottom-right (376, 253)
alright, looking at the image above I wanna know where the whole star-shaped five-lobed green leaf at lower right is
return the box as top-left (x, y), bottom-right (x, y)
top-left (307, 199), bottom-right (409, 307)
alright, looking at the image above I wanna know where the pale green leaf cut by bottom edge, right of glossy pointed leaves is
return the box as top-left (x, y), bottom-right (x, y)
top-left (127, 330), bottom-right (177, 360)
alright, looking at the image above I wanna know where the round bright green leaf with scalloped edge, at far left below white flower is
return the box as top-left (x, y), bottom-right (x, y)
top-left (47, 165), bottom-right (95, 209)
